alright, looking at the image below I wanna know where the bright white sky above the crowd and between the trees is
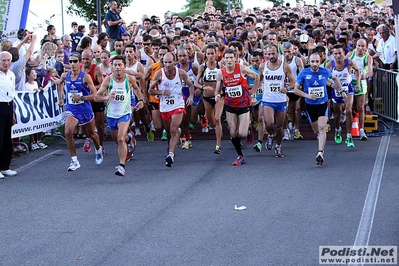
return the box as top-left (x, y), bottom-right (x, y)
top-left (26, 0), bottom-right (265, 38)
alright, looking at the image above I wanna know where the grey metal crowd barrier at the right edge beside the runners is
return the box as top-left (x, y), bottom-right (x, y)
top-left (373, 68), bottom-right (399, 122)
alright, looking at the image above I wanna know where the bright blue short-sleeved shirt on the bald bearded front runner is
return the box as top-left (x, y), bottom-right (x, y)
top-left (297, 68), bottom-right (332, 104)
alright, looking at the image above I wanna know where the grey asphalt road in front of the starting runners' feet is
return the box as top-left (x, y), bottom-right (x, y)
top-left (0, 128), bottom-right (399, 266)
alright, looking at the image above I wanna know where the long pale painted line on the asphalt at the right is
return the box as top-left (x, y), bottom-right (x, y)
top-left (353, 135), bottom-right (391, 260)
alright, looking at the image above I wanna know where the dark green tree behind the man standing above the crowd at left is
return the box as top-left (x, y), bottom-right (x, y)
top-left (67, 0), bottom-right (133, 21)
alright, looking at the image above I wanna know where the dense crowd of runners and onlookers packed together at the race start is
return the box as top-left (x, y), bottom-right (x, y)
top-left (0, 0), bottom-right (397, 176)
